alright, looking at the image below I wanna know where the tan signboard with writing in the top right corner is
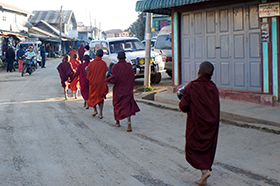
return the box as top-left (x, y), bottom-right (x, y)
top-left (259, 2), bottom-right (280, 17)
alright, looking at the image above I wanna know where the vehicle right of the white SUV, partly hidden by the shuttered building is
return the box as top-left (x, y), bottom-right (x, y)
top-left (154, 26), bottom-right (172, 77)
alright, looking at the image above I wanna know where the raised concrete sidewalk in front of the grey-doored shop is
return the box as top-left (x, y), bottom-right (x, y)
top-left (135, 89), bottom-right (280, 134)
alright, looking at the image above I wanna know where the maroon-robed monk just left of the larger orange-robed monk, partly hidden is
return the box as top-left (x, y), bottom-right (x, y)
top-left (74, 55), bottom-right (90, 109)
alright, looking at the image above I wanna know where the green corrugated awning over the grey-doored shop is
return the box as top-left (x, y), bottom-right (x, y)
top-left (135, 0), bottom-right (208, 15)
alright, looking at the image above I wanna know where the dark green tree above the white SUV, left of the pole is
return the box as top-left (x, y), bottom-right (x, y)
top-left (126, 12), bottom-right (146, 41)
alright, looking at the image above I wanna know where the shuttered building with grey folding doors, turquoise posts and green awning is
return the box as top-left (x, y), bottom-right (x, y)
top-left (136, 0), bottom-right (280, 105)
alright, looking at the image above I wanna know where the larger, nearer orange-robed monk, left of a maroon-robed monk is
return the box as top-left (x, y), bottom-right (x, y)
top-left (87, 49), bottom-right (109, 119)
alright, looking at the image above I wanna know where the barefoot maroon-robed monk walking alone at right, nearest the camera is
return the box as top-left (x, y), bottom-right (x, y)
top-left (179, 61), bottom-right (220, 186)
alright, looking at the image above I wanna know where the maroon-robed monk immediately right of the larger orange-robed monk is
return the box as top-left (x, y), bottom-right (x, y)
top-left (106, 52), bottom-right (140, 132)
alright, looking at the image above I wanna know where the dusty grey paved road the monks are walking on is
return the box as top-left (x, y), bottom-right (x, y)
top-left (0, 59), bottom-right (280, 186)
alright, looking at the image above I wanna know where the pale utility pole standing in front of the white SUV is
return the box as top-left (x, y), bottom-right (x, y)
top-left (144, 13), bottom-right (152, 86)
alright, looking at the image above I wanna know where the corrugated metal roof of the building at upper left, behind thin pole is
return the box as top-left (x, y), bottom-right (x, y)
top-left (29, 10), bottom-right (73, 24)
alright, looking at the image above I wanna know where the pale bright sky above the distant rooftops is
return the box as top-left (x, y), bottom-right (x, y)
top-left (7, 0), bottom-right (138, 31)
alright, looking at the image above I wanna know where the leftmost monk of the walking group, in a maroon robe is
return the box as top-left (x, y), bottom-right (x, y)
top-left (57, 54), bottom-right (75, 100)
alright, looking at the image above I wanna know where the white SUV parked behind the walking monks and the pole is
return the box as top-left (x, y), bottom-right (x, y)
top-left (90, 37), bottom-right (165, 83)
